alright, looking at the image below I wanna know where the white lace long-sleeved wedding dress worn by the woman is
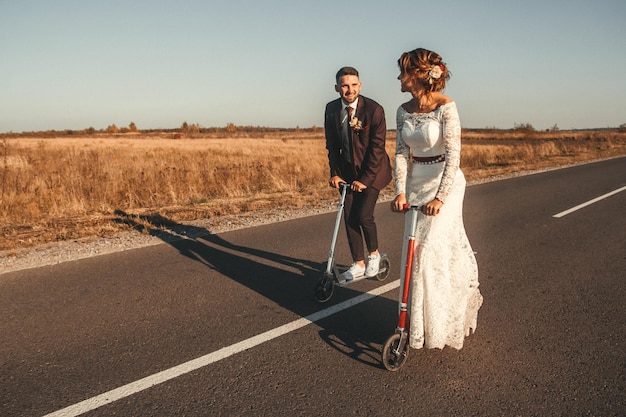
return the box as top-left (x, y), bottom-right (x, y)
top-left (395, 102), bottom-right (483, 349)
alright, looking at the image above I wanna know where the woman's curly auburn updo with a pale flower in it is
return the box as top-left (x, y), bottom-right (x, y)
top-left (398, 48), bottom-right (451, 92)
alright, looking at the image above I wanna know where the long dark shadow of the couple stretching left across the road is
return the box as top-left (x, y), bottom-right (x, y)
top-left (115, 210), bottom-right (397, 368)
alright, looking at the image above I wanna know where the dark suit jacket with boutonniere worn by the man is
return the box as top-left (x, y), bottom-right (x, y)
top-left (324, 96), bottom-right (392, 190)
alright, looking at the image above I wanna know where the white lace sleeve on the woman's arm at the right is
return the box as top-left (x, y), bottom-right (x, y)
top-left (435, 102), bottom-right (461, 202)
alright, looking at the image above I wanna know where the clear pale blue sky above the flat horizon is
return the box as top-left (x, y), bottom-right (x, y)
top-left (0, 0), bottom-right (626, 132)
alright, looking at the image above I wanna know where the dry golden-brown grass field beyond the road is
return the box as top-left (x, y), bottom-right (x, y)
top-left (0, 129), bottom-right (626, 251)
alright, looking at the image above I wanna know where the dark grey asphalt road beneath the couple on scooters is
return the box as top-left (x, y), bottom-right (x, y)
top-left (0, 158), bottom-right (626, 416)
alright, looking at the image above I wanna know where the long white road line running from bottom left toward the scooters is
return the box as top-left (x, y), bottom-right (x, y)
top-left (44, 280), bottom-right (400, 417)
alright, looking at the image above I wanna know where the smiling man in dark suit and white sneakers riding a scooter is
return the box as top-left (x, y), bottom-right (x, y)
top-left (324, 67), bottom-right (391, 282)
